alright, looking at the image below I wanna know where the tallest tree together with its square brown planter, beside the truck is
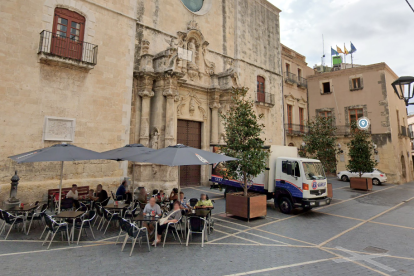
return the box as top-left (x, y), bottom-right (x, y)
top-left (220, 87), bottom-right (269, 219)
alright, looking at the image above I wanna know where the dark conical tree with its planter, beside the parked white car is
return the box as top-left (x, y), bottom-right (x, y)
top-left (346, 123), bottom-right (377, 191)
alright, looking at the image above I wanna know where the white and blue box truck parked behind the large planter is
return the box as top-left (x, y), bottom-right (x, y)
top-left (210, 146), bottom-right (331, 214)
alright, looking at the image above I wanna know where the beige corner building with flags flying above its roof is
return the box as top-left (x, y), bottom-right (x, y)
top-left (308, 63), bottom-right (413, 184)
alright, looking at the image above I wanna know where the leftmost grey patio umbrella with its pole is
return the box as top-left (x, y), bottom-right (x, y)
top-left (9, 143), bottom-right (102, 213)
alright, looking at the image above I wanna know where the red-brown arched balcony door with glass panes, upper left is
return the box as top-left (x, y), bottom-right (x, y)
top-left (51, 8), bottom-right (85, 60)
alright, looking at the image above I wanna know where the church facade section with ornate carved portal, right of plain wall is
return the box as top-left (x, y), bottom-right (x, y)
top-left (130, 0), bottom-right (283, 192)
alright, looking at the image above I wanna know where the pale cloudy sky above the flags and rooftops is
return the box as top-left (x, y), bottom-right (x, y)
top-left (268, 0), bottom-right (414, 113)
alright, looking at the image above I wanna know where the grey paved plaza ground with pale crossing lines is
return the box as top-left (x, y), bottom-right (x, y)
top-left (0, 179), bottom-right (414, 276)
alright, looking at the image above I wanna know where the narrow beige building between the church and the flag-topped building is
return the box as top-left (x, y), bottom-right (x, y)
top-left (282, 44), bottom-right (315, 149)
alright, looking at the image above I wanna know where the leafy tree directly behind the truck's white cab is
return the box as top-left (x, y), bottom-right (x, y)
top-left (300, 116), bottom-right (339, 172)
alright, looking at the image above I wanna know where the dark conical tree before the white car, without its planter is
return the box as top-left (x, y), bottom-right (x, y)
top-left (346, 123), bottom-right (377, 177)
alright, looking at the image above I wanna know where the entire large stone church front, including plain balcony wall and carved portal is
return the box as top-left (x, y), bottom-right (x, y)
top-left (0, 0), bottom-right (284, 205)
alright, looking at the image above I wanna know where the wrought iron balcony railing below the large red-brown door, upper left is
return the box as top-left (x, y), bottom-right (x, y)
top-left (38, 31), bottom-right (98, 65)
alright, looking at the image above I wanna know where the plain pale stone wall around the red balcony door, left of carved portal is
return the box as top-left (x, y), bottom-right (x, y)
top-left (0, 0), bottom-right (136, 205)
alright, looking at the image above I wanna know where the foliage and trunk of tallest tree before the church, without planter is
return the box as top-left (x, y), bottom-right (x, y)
top-left (220, 87), bottom-right (269, 196)
